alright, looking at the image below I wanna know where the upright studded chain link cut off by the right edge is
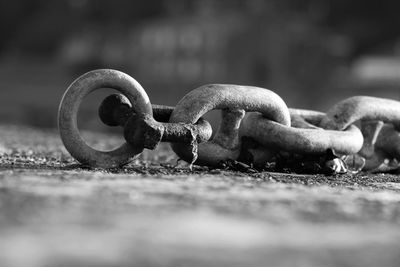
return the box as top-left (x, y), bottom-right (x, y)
top-left (320, 96), bottom-right (400, 170)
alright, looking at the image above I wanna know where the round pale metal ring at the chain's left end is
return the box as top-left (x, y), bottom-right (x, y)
top-left (58, 69), bottom-right (152, 168)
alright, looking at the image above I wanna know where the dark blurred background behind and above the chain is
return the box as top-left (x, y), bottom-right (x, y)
top-left (0, 0), bottom-right (400, 130)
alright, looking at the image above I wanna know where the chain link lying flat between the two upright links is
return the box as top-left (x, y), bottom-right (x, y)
top-left (240, 109), bottom-right (363, 173)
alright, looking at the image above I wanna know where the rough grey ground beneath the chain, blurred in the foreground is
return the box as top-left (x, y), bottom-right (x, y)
top-left (0, 126), bottom-right (400, 267)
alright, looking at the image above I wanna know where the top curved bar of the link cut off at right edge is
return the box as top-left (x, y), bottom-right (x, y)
top-left (320, 96), bottom-right (400, 130)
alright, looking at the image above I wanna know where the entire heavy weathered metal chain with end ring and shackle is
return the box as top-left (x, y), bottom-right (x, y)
top-left (58, 69), bottom-right (400, 174)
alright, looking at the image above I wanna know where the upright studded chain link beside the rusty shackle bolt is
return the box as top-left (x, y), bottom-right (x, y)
top-left (170, 84), bottom-right (290, 166)
